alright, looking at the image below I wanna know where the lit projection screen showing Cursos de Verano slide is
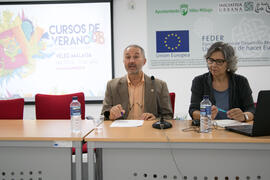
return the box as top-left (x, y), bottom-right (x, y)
top-left (0, 0), bottom-right (114, 102)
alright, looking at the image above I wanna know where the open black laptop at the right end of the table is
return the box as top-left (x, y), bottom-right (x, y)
top-left (225, 90), bottom-right (270, 136)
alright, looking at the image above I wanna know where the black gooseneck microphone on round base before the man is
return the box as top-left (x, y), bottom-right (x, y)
top-left (151, 76), bottom-right (172, 129)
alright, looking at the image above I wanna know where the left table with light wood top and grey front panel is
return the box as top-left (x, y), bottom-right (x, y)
top-left (0, 120), bottom-right (93, 180)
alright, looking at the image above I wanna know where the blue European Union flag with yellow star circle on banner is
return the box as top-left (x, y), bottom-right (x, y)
top-left (156, 31), bottom-right (189, 53)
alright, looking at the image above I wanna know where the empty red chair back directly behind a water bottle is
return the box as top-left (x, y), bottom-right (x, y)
top-left (35, 92), bottom-right (85, 119)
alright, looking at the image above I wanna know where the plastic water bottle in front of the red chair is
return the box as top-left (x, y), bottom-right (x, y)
top-left (70, 96), bottom-right (81, 134)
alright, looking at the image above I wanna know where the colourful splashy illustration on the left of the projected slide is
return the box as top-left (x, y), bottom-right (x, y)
top-left (0, 11), bottom-right (49, 98)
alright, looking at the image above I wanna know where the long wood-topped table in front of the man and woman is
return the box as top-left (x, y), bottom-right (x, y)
top-left (85, 121), bottom-right (270, 180)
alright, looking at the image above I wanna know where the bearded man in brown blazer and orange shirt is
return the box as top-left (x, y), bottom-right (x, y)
top-left (101, 45), bottom-right (173, 120)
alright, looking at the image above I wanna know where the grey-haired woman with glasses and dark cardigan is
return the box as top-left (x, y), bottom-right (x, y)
top-left (189, 42), bottom-right (255, 122)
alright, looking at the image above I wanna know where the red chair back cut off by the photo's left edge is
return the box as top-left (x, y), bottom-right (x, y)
top-left (0, 98), bottom-right (24, 119)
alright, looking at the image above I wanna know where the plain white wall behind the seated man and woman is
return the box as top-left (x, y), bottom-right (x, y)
top-left (2, 0), bottom-right (270, 119)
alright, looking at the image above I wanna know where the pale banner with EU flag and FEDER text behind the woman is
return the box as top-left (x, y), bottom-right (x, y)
top-left (147, 0), bottom-right (270, 68)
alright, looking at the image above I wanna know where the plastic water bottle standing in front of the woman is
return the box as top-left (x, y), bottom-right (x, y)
top-left (200, 95), bottom-right (212, 133)
